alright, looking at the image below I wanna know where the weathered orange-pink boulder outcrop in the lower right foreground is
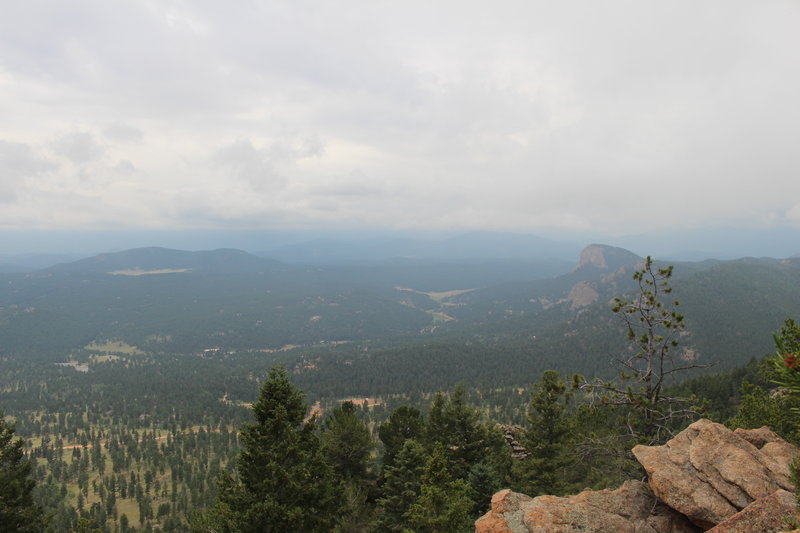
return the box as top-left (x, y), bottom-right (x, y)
top-left (475, 420), bottom-right (798, 533)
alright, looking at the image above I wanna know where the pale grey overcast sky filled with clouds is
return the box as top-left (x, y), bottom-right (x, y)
top-left (0, 0), bottom-right (800, 233)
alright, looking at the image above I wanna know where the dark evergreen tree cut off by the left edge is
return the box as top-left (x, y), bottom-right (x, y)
top-left (0, 411), bottom-right (44, 533)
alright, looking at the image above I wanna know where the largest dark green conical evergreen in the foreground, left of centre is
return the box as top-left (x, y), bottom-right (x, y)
top-left (198, 367), bottom-right (341, 533)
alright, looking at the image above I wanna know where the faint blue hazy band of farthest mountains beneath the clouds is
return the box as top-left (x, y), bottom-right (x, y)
top-left (0, 227), bottom-right (800, 272)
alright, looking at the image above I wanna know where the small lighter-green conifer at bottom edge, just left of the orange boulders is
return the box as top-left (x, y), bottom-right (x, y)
top-left (407, 444), bottom-right (475, 533)
